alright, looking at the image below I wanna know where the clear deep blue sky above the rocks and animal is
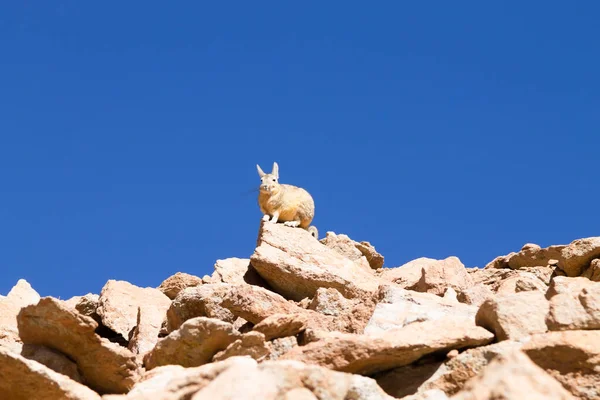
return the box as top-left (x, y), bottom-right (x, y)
top-left (0, 0), bottom-right (600, 298)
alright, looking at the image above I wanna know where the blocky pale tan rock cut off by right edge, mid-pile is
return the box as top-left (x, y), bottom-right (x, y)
top-left (546, 276), bottom-right (600, 331)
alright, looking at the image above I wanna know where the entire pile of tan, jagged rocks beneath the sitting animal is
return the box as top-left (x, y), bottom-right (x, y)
top-left (0, 223), bottom-right (600, 400)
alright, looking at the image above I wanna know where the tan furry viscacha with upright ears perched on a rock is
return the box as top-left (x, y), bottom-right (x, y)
top-left (256, 163), bottom-right (319, 238)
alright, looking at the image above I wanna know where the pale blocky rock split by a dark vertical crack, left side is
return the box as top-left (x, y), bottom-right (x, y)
top-left (96, 279), bottom-right (171, 351)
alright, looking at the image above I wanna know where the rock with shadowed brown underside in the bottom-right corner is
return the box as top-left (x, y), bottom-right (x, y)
top-left (522, 331), bottom-right (600, 400)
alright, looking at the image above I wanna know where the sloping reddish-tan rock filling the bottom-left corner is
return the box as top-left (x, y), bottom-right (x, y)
top-left (0, 346), bottom-right (100, 400)
